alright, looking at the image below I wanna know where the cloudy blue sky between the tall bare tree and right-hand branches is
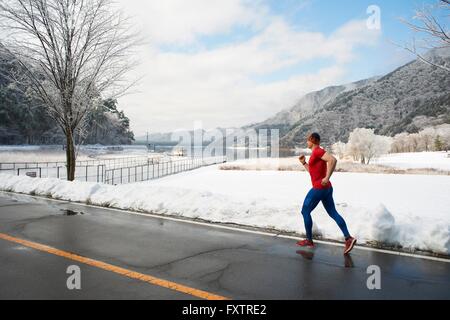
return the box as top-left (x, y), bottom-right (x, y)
top-left (117, 0), bottom-right (435, 137)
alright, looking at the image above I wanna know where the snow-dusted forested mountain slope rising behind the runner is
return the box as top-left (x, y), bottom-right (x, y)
top-left (253, 49), bottom-right (450, 147)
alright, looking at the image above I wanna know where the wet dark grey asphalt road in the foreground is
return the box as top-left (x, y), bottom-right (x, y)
top-left (0, 193), bottom-right (450, 300)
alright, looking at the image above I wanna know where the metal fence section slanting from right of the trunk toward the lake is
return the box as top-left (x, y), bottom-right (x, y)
top-left (105, 157), bottom-right (227, 185)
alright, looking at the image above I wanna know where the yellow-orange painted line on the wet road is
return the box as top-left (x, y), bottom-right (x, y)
top-left (0, 233), bottom-right (228, 300)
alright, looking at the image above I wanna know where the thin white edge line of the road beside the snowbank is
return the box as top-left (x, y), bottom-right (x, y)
top-left (0, 190), bottom-right (450, 263)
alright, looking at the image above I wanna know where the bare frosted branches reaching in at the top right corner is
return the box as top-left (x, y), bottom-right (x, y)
top-left (401, 0), bottom-right (450, 72)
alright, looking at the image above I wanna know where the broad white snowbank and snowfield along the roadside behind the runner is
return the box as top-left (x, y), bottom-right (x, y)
top-left (0, 166), bottom-right (450, 255)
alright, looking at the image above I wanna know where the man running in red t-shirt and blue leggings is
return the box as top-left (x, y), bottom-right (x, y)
top-left (297, 133), bottom-right (356, 254)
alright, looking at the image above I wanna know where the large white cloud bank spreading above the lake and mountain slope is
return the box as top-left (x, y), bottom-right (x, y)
top-left (115, 0), bottom-right (379, 135)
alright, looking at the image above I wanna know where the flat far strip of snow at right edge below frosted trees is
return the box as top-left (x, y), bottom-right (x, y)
top-left (372, 152), bottom-right (450, 171)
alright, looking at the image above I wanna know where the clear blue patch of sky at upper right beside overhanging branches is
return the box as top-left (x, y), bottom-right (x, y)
top-left (296, 0), bottom-right (436, 80)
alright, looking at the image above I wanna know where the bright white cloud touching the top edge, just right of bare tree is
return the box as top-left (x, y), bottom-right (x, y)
top-left (119, 0), bottom-right (268, 45)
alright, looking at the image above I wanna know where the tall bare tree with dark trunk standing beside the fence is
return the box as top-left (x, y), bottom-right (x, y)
top-left (0, 0), bottom-right (138, 181)
